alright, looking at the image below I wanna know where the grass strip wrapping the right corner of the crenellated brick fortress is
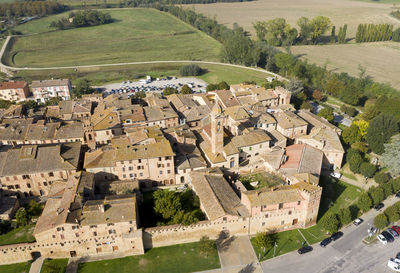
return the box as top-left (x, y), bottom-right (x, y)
top-left (251, 176), bottom-right (363, 261)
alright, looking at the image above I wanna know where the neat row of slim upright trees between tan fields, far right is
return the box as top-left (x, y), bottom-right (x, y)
top-left (356, 24), bottom-right (393, 43)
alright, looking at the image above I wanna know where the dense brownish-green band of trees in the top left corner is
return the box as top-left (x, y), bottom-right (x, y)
top-left (0, 1), bottom-right (66, 18)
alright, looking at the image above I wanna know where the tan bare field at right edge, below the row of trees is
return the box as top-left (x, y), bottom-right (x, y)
top-left (291, 42), bottom-right (400, 89)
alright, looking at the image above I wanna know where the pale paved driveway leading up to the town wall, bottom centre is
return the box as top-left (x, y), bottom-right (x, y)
top-left (217, 236), bottom-right (262, 273)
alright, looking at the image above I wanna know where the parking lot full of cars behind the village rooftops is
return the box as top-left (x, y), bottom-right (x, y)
top-left (98, 77), bottom-right (207, 94)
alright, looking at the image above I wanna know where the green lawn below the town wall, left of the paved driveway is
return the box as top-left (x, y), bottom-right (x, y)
top-left (78, 240), bottom-right (220, 273)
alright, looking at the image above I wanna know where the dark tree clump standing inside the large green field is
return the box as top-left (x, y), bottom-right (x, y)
top-left (50, 10), bottom-right (112, 30)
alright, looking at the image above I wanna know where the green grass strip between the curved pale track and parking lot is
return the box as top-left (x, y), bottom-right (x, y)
top-left (14, 63), bottom-right (270, 85)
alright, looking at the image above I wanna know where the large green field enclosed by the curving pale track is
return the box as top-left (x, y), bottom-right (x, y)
top-left (4, 9), bottom-right (221, 67)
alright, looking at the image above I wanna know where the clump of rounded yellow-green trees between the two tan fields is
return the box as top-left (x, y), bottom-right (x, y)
top-left (253, 16), bottom-right (347, 46)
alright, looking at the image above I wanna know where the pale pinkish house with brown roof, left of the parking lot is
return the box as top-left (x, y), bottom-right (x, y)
top-left (31, 79), bottom-right (72, 103)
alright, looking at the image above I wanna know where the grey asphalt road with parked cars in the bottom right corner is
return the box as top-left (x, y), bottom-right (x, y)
top-left (261, 196), bottom-right (400, 273)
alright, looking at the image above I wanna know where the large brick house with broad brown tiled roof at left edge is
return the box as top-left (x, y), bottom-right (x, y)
top-left (0, 142), bottom-right (81, 197)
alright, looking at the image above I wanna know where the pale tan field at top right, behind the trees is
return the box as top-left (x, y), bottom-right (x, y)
top-left (187, 0), bottom-right (400, 37)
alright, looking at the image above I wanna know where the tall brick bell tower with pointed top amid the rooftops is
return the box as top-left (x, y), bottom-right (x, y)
top-left (210, 100), bottom-right (224, 154)
